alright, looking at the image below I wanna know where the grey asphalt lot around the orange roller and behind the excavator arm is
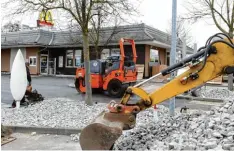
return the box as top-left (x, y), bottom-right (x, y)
top-left (1, 75), bottom-right (222, 110)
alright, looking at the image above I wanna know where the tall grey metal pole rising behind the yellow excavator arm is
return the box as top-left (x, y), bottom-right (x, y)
top-left (169, 0), bottom-right (177, 116)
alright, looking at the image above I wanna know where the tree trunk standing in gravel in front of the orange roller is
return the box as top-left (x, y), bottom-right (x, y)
top-left (83, 31), bottom-right (93, 105)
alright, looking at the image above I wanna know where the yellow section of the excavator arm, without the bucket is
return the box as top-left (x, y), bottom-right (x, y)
top-left (121, 36), bottom-right (234, 110)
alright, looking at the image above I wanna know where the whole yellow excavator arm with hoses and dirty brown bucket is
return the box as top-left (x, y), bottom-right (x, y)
top-left (80, 33), bottom-right (234, 150)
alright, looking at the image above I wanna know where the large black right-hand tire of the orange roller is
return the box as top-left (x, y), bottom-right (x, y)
top-left (107, 80), bottom-right (124, 97)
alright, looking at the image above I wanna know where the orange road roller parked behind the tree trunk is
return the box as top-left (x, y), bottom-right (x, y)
top-left (75, 38), bottom-right (137, 97)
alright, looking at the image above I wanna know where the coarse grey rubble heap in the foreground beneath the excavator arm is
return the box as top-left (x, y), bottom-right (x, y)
top-left (114, 98), bottom-right (234, 150)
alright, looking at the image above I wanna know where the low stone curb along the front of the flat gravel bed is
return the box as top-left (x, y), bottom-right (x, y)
top-left (4, 125), bottom-right (82, 135)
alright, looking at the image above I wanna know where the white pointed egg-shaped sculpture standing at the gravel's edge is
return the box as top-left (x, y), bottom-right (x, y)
top-left (10, 49), bottom-right (27, 108)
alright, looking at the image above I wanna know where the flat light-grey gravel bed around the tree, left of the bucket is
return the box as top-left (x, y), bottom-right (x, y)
top-left (1, 98), bottom-right (106, 128)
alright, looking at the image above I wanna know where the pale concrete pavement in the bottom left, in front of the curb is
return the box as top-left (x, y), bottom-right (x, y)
top-left (1, 133), bottom-right (81, 150)
